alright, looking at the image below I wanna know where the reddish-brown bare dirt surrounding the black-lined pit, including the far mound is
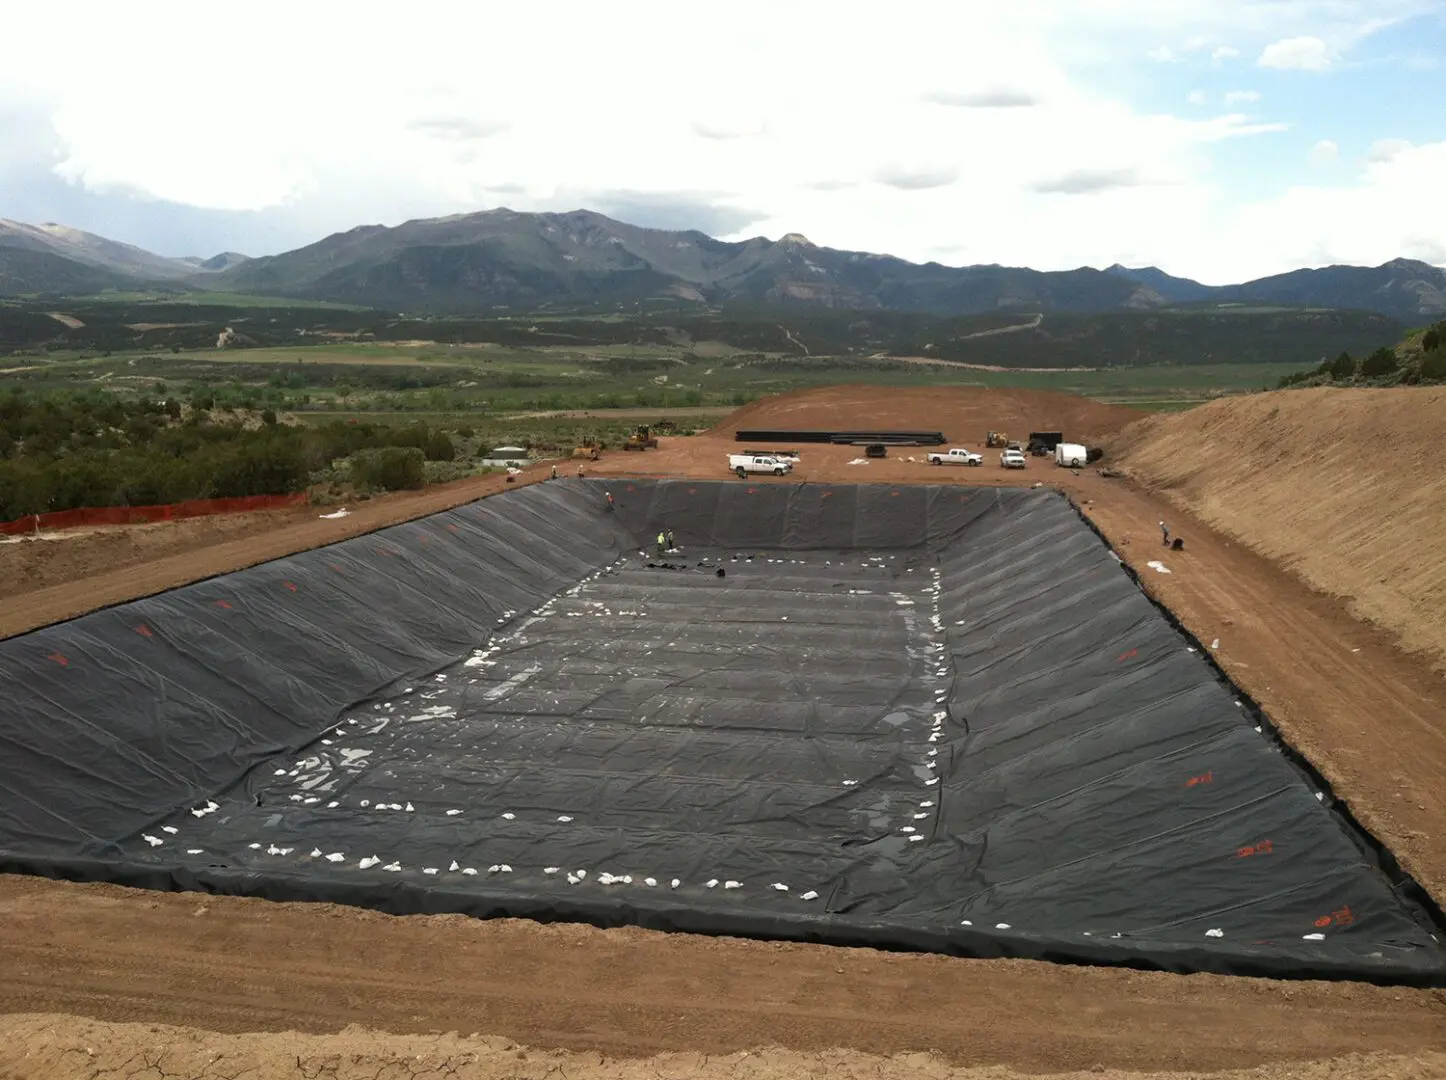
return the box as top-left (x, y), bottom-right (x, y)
top-left (0, 387), bottom-right (1446, 1080)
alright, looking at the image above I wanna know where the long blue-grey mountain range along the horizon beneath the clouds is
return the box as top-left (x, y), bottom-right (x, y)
top-left (0, 210), bottom-right (1446, 322)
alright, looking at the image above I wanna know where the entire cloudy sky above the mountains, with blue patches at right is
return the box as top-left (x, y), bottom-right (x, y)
top-left (0, 0), bottom-right (1446, 283)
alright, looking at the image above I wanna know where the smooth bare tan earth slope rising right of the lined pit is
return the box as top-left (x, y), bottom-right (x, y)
top-left (1106, 387), bottom-right (1446, 671)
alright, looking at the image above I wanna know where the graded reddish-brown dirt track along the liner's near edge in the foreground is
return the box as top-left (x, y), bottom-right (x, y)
top-left (0, 878), bottom-right (1446, 1071)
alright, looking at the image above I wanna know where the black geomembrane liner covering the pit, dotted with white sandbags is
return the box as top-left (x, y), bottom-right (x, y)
top-left (0, 479), bottom-right (1446, 983)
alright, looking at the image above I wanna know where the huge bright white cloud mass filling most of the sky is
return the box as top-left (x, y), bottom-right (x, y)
top-left (0, 0), bottom-right (1446, 279)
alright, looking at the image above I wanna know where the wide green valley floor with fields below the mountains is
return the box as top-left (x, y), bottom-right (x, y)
top-left (0, 293), bottom-right (1353, 441)
